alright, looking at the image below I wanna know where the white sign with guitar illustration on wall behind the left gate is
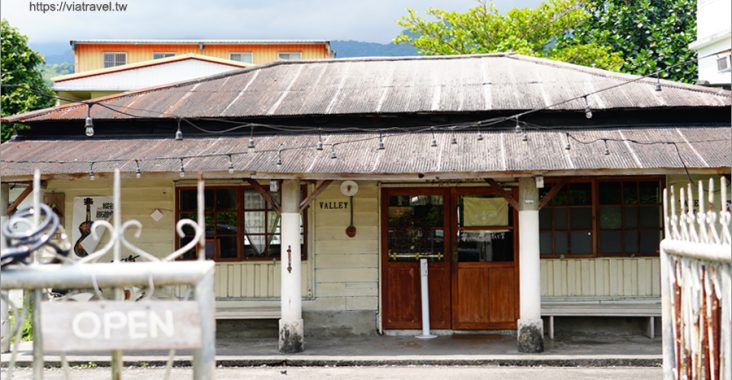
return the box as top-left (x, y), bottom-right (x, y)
top-left (71, 196), bottom-right (113, 257)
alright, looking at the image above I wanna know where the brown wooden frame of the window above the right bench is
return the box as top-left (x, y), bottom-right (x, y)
top-left (539, 175), bottom-right (666, 259)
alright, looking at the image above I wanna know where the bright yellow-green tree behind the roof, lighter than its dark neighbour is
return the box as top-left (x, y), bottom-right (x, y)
top-left (394, 0), bottom-right (624, 70)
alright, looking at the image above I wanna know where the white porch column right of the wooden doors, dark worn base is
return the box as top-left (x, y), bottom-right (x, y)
top-left (517, 177), bottom-right (544, 352)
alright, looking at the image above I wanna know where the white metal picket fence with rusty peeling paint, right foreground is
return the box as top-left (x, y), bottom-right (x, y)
top-left (661, 177), bottom-right (732, 380)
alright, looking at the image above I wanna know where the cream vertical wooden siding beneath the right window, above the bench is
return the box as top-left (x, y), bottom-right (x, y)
top-left (541, 257), bottom-right (661, 297)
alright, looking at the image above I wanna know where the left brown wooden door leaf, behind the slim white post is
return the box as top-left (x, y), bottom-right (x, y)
top-left (381, 188), bottom-right (451, 329)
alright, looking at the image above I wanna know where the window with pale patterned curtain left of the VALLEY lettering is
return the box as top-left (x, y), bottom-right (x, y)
top-left (176, 186), bottom-right (307, 261)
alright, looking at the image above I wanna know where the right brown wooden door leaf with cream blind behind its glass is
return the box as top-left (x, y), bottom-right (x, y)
top-left (449, 188), bottom-right (518, 330)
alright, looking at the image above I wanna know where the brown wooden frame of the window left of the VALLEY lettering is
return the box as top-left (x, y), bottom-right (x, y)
top-left (173, 184), bottom-right (309, 263)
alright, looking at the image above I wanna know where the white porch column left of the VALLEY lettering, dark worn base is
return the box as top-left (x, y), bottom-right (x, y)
top-left (279, 180), bottom-right (304, 354)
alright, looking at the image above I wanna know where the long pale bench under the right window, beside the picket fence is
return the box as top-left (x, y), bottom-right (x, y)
top-left (541, 297), bottom-right (661, 339)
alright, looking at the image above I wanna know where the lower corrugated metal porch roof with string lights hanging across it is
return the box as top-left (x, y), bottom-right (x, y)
top-left (0, 126), bottom-right (732, 178)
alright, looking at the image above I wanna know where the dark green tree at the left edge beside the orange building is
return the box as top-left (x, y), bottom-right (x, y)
top-left (0, 20), bottom-right (54, 142)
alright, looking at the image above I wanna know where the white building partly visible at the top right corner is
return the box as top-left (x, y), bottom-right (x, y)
top-left (689, 0), bottom-right (732, 88)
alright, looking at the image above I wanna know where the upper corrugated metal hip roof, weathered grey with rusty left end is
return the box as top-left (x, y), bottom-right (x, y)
top-left (7, 54), bottom-right (732, 123)
